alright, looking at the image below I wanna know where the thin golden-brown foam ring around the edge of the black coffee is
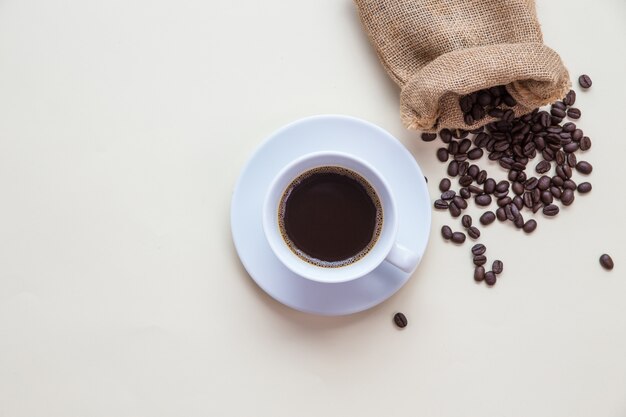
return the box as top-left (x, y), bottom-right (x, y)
top-left (278, 166), bottom-right (383, 268)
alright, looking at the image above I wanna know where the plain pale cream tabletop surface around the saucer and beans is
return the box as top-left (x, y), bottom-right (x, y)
top-left (0, 0), bottom-right (626, 417)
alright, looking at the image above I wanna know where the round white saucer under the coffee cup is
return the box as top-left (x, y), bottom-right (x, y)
top-left (231, 115), bottom-right (431, 315)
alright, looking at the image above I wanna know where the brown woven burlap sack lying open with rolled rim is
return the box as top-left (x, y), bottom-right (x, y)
top-left (355, 0), bottom-right (570, 131)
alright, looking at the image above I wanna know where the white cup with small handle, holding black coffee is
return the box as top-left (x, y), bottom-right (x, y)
top-left (263, 152), bottom-right (420, 283)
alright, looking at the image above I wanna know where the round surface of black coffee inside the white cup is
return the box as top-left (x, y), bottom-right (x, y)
top-left (278, 166), bottom-right (383, 268)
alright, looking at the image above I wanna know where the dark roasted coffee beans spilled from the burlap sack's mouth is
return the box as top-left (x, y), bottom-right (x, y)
top-left (422, 75), bottom-right (596, 285)
